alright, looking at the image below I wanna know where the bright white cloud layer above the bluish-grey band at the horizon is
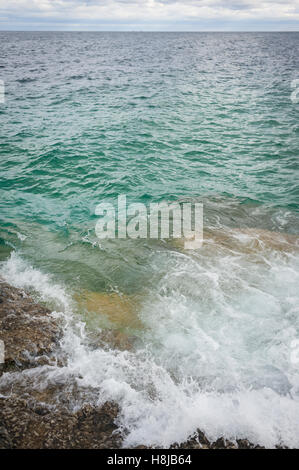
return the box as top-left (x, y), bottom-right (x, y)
top-left (0, 0), bottom-right (299, 29)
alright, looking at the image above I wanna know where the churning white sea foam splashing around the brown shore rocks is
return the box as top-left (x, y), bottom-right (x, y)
top-left (1, 246), bottom-right (299, 447)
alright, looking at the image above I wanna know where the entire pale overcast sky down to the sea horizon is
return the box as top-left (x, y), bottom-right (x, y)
top-left (0, 0), bottom-right (299, 31)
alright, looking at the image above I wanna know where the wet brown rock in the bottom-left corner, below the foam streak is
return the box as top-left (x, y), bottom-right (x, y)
top-left (0, 395), bottom-right (121, 449)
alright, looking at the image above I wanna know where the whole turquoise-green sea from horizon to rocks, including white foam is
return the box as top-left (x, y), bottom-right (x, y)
top-left (0, 32), bottom-right (299, 447)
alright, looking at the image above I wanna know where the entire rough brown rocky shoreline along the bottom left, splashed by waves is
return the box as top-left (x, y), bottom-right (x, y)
top-left (0, 280), bottom-right (254, 449)
